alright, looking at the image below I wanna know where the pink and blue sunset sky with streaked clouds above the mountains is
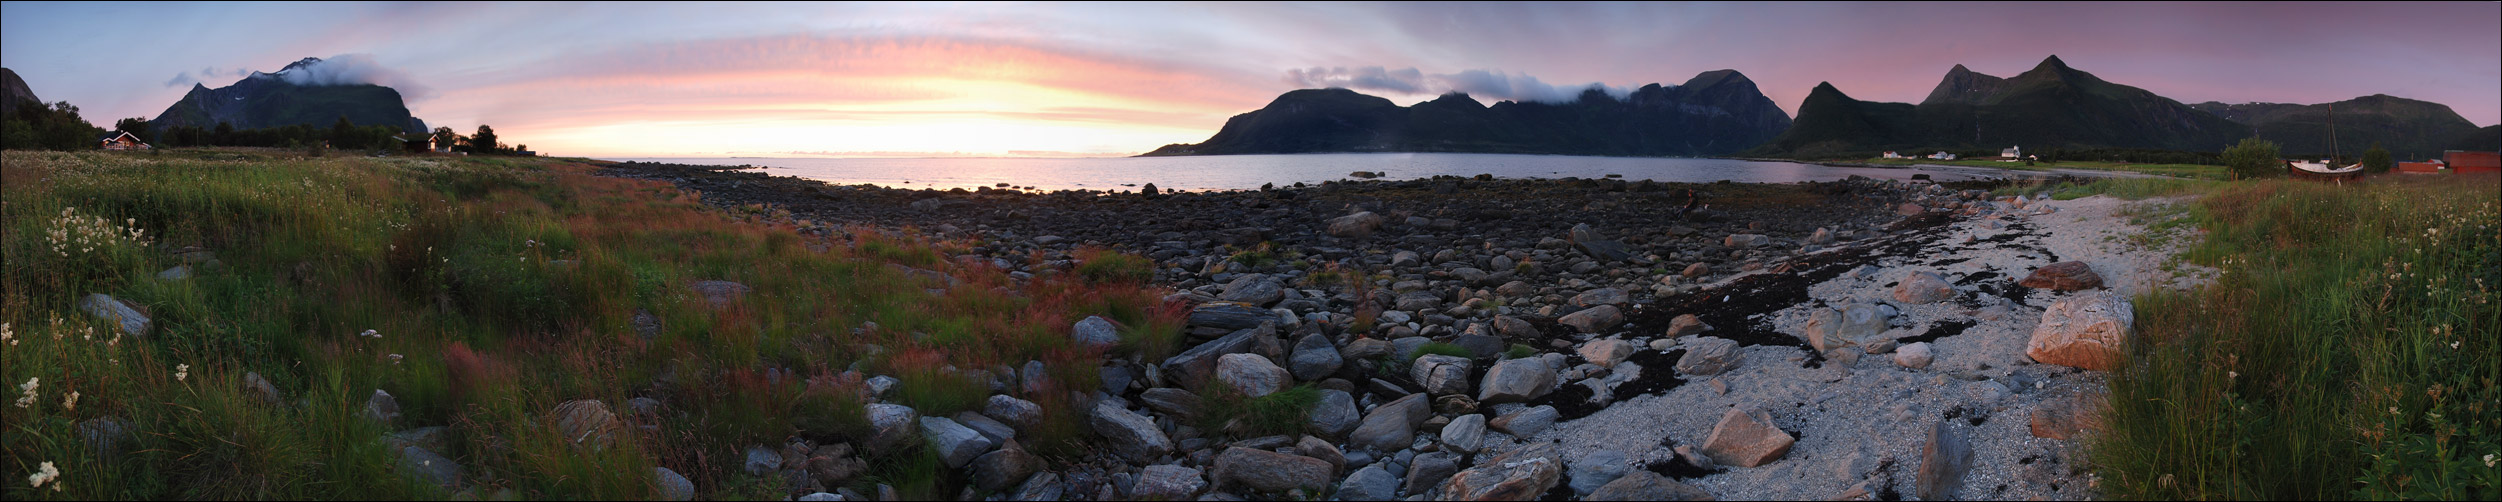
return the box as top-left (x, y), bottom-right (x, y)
top-left (0, 2), bottom-right (2502, 157)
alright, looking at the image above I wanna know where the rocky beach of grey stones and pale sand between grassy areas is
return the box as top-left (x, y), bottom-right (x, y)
top-left (600, 162), bottom-right (2202, 500)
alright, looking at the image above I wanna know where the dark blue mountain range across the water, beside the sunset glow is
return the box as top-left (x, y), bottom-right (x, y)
top-left (1146, 70), bottom-right (1789, 157)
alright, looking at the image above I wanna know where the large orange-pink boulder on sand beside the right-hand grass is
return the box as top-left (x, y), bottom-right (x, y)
top-left (2024, 290), bottom-right (2137, 372)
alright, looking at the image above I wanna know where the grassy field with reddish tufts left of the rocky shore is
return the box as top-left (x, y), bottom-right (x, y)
top-left (0, 150), bottom-right (1181, 500)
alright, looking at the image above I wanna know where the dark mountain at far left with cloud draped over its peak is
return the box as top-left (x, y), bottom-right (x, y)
top-left (148, 57), bottom-right (425, 132)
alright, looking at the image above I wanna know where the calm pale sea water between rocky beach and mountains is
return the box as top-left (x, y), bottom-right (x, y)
top-left (613, 152), bottom-right (2007, 190)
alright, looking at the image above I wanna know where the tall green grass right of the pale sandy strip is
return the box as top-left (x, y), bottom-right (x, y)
top-left (2092, 177), bottom-right (2502, 500)
